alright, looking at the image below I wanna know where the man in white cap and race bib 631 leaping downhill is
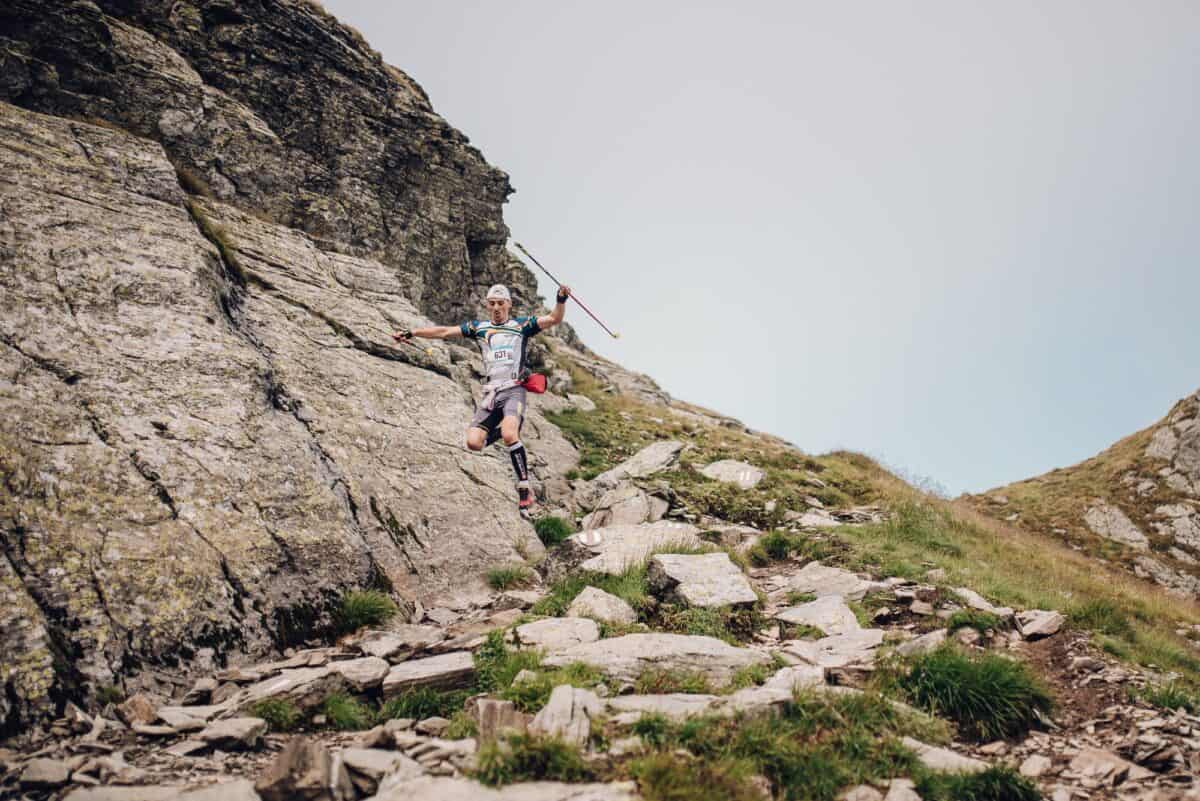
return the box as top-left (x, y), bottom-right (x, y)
top-left (391, 284), bottom-right (571, 512)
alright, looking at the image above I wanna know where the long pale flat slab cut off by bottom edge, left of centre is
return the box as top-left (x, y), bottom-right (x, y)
top-left (372, 776), bottom-right (642, 801)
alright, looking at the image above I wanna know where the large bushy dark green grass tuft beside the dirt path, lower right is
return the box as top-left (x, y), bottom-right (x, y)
top-left (898, 646), bottom-right (1052, 742)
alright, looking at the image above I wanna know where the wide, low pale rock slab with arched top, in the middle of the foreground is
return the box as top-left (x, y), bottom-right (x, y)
top-left (544, 633), bottom-right (770, 685)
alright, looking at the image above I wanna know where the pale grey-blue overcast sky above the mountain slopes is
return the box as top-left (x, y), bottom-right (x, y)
top-left (324, 0), bottom-right (1200, 494)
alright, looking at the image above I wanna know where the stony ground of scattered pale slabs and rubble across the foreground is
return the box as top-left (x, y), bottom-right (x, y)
top-left (0, 442), bottom-right (1200, 801)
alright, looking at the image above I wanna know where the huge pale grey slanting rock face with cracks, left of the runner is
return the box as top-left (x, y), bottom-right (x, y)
top-left (0, 90), bottom-right (570, 728)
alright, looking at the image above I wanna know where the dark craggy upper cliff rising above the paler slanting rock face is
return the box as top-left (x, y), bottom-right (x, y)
top-left (0, 0), bottom-right (536, 321)
